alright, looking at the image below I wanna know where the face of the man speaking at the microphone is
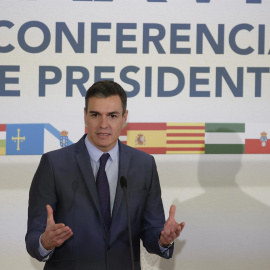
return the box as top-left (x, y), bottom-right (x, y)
top-left (84, 95), bottom-right (128, 152)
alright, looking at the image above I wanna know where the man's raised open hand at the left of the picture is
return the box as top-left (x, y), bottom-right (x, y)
top-left (41, 204), bottom-right (73, 250)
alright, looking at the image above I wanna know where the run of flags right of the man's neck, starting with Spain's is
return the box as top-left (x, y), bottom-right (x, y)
top-left (120, 123), bottom-right (270, 154)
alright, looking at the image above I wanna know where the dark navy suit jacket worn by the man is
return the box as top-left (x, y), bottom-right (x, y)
top-left (26, 135), bottom-right (173, 270)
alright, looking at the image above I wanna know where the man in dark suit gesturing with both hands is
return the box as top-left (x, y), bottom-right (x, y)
top-left (26, 81), bottom-right (184, 270)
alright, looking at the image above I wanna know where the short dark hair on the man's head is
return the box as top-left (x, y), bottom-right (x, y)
top-left (85, 81), bottom-right (127, 115)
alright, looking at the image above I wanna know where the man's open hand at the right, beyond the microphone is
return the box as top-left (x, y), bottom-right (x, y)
top-left (159, 205), bottom-right (185, 246)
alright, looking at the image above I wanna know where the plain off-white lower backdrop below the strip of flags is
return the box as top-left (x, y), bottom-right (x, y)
top-left (0, 155), bottom-right (270, 270)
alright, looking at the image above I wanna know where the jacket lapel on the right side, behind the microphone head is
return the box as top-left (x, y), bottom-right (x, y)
top-left (112, 140), bottom-right (130, 220)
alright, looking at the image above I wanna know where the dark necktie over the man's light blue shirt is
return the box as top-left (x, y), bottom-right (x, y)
top-left (96, 153), bottom-right (111, 231)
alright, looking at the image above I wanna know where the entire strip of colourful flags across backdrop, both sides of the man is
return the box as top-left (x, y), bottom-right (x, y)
top-left (0, 123), bottom-right (270, 155)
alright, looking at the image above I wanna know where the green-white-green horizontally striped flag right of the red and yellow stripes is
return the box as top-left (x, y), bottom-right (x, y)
top-left (205, 123), bottom-right (245, 154)
